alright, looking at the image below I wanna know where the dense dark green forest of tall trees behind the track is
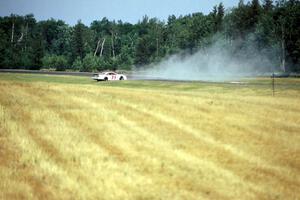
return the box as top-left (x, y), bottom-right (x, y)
top-left (0, 0), bottom-right (300, 72)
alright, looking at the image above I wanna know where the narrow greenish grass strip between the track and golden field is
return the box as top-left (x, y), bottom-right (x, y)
top-left (0, 73), bottom-right (300, 95)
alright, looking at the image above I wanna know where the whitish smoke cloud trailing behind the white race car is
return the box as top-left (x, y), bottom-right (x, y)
top-left (142, 35), bottom-right (279, 81)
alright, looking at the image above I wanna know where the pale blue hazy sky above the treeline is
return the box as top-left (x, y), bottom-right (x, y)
top-left (0, 0), bottom-right (238, 25)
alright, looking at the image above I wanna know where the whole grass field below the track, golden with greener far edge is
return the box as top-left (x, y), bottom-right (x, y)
top-left (0, 74), bottom-right (300, 200)
